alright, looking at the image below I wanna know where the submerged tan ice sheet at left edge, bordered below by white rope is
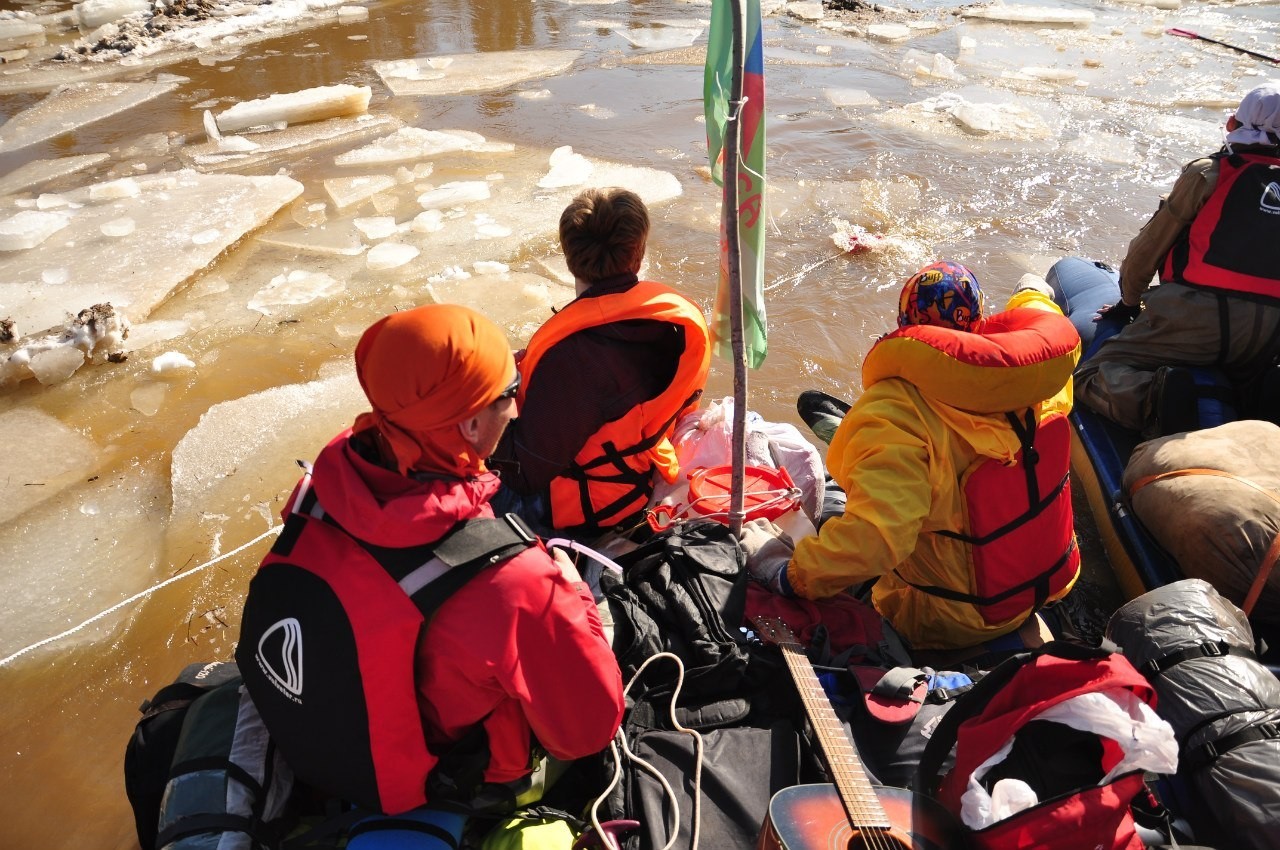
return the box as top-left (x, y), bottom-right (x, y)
top-left (0, 455), bottom-right (168, 657)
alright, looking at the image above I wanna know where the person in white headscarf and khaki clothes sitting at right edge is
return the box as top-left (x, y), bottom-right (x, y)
top-left (1075, 82), bottom-right (1280, 437)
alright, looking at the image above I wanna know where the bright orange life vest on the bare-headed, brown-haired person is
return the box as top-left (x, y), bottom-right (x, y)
top-left (517, 280), bottom-right (710, 534)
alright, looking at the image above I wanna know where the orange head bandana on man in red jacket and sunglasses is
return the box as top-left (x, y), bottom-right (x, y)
top-left (353, 303), bottom-right (516, 477)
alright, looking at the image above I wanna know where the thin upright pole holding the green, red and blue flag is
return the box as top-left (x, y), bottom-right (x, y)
top-left (721, 0), bottom-right (746, 536)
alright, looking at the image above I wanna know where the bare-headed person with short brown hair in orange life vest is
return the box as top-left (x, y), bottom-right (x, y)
top-left (493, 188), bottom-right (710, 538)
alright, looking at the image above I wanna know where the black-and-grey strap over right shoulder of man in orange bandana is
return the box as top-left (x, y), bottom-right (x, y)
top-left (410, 513), bottom-right (538, 617)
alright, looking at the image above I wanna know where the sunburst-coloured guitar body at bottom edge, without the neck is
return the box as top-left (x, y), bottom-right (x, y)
top-left (755, 785), bottom-right (964, 850)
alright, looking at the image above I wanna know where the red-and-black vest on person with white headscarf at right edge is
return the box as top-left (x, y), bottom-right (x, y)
top-left (1160, 154), bottom-right (1280, 298)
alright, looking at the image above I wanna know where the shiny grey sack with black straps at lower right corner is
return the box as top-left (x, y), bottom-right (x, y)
top-left (1107, 579), bottom-right (1280, 850)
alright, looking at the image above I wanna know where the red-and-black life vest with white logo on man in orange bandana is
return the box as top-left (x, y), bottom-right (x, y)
top-left (236, 477), bottom-right (535, 814)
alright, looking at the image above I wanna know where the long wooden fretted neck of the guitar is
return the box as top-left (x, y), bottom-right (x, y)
top-left (778, 641), bottom-right (891, 828)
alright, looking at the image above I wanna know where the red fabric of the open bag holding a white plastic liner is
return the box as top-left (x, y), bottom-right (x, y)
top-left (916, 643), bottom-right (1156, 850)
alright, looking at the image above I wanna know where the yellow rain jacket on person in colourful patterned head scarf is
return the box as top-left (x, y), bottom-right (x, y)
top-left (786, 289), bottom-right (1080, 649)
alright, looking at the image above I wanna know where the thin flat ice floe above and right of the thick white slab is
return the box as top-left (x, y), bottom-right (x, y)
top-left (370, 50), bottom-right (582, 96)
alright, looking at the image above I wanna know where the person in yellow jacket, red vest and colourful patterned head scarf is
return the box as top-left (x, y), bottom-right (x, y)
top-left (742, 261), bottom-right (1080, 650)
